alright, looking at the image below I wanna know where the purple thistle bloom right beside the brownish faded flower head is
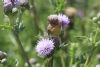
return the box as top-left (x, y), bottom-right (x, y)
top-left (58, 14), bottom-right (70, 28)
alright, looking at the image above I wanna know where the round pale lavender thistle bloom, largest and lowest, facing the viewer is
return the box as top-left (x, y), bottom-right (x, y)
top-left (36, 38), bottom-right (55, 57)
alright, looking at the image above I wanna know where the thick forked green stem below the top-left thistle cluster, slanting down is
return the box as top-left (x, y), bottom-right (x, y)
top-left (10, 10), bottom-right (31, 67)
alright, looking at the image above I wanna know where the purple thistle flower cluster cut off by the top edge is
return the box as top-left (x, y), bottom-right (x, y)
top-left (3, 0), bottom-right (29, 13)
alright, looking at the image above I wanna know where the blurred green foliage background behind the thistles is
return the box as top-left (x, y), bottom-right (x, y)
top-left (0, 0), bottom-right (100, 67)
